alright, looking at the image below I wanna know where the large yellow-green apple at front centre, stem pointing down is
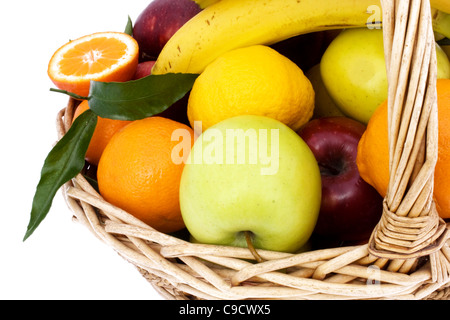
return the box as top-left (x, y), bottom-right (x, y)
top-left (180, 115), bottom-right (322, 252)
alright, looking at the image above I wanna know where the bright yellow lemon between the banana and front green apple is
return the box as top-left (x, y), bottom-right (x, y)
top-left (188, 45), bottom-right (314, 130)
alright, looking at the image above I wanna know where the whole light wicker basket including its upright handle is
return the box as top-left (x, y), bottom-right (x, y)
top-left (57, 0), bottom-right (450, 300)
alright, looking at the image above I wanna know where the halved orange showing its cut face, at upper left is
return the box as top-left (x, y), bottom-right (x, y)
top-left (48, 32), bottom-right (139, 97)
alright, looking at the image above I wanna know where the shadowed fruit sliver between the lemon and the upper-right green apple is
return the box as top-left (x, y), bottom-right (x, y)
top-left (305, 63), bottom-right (344, 119)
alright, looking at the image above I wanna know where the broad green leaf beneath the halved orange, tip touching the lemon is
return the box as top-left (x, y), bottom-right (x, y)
top-left (89, 73), bottom-right (198, 120)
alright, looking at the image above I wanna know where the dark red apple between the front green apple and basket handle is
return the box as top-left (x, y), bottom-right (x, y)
top-left (298, 117), bottom-right (383, 241)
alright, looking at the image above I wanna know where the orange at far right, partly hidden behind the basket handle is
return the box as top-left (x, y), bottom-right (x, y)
top-left (356, 79), bottom-right (450, 218)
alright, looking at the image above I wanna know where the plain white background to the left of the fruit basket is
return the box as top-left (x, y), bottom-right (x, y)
top-left (0, 0), bottom-right (165, 300)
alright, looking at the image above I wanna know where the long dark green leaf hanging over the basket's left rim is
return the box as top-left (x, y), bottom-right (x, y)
top-left (23, 110), bottom-right (97, 241)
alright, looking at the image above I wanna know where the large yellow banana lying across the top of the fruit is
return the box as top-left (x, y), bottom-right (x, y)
top-left (152, 0), bottom-right (450, 74)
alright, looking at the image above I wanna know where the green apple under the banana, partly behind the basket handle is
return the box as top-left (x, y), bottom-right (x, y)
top-left (320, 28), bottom-right (450, 124)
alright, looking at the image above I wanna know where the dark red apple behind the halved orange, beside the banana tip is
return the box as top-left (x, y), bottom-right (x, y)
top-left (133, 0), bottom-right (201, 59)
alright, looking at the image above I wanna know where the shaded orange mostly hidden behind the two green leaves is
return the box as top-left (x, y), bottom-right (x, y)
top-left (73, 100), bottom-right (131, 166)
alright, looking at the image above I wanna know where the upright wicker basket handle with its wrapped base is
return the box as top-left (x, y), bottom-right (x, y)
top-left (369, 0), bottom-right (450, 278)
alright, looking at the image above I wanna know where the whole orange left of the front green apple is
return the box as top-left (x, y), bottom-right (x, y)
top-left (97, 117), bottom-right (194, 233)
